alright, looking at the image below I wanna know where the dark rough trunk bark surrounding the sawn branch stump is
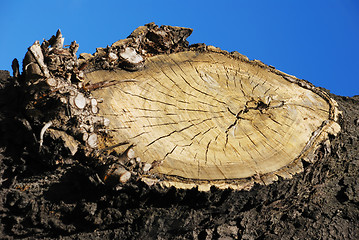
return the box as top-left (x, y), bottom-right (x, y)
top-left (0, 40), bottom-right (359, 239)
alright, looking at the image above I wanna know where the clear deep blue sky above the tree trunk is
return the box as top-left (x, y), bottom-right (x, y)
top-left (0, 0), bottom-right (359, 96)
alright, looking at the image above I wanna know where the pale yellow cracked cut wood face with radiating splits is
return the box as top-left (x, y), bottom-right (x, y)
top-left (85, 51), bottom-right (340, 190)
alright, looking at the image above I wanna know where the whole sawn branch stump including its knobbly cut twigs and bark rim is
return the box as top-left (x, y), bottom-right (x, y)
top-left (18, 24), bottom-right (340, 191)
